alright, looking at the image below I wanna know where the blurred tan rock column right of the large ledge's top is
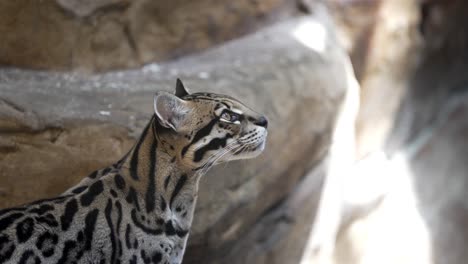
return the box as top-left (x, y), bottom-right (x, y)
top-left (330, 0), bottom-right (421, 158)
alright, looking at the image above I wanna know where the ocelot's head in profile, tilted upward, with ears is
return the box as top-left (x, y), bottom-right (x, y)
top-left (154, 79), bottom-right (268, 169)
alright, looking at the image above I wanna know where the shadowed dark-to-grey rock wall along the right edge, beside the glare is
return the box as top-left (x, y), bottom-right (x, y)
top-left (389, 0), bottom-right (468, 264)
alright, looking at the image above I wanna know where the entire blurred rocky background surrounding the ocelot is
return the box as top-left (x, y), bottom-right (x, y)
top-left (0, 0), bottom-right (468, 264)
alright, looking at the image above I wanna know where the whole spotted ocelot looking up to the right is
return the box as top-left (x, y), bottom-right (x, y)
top-left (0, 80), bottom-right (267, 264)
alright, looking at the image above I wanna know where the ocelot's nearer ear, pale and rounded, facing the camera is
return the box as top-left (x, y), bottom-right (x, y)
top-left (154, 92), bottom-right (190, 132)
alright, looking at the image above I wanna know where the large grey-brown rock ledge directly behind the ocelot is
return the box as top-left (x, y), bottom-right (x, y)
top-left (0, 8), bottom-right (350, 263)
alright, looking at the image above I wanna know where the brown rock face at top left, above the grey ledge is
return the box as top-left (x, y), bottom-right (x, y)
top-left (0, 0), bottom-right (296, 72)
